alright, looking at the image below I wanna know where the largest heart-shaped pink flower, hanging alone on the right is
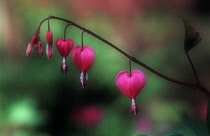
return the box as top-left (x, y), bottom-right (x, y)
top-left (116, 70), bottom-right (146, 115)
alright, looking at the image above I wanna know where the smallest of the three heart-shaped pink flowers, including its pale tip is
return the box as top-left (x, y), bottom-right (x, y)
top-left (56, 38), bottom-right (74, 73)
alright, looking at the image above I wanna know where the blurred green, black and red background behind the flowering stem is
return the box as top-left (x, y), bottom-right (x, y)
top-left (0, 0), bottom-right (210, 136)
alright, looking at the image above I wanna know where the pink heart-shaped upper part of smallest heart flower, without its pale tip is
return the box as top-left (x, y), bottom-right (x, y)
top-left (56, 38), bottom-right (74, 57)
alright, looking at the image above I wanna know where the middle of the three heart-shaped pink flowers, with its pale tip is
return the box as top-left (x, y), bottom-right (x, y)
top-left (72, 46), bottom-right (95, 88)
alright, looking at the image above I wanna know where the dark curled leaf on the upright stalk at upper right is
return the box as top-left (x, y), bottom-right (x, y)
top-left (180, 17), bottom-right (202, 52)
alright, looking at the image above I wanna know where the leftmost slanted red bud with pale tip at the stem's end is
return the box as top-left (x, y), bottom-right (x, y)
top-left (26, 34), bottom-right (39, 56)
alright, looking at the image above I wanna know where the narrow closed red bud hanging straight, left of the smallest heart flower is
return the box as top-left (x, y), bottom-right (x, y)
top-left (46, 30), bottom-right (53, 59)
